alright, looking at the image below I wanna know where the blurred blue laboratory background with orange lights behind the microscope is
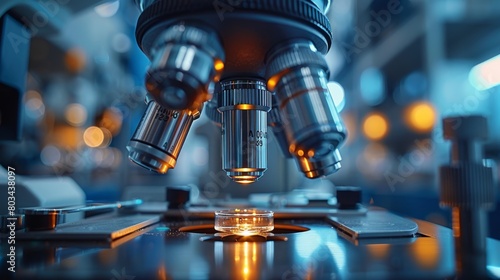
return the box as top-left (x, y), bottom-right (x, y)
top-left (0, 0), bottom-right (500, 238)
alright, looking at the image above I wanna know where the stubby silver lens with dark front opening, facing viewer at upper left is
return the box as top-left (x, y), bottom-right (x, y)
top-left (146, 24), bottom-right (224, 110)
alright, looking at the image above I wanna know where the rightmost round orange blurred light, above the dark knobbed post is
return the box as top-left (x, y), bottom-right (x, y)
top-left (405, 102), bottom-right (436, 132)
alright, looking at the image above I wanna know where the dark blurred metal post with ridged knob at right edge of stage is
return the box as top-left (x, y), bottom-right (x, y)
top-left (440, 116), bottom-right (495, 279)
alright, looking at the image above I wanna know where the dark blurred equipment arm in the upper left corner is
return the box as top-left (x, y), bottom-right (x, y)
top-left (0, 0), bottom-right (110, 141)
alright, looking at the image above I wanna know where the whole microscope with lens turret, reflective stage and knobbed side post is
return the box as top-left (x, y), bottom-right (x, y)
top-left (0, 0), bottom-right (500, 279)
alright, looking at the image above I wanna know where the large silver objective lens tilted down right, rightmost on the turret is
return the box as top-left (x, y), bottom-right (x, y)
top-left (267, 41), bottom-right (347, 178)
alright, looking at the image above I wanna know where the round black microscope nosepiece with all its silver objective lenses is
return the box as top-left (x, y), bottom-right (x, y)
top-left (129, 0), bottom-right (346, 184)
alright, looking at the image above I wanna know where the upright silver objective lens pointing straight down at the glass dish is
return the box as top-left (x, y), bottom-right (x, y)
top-left (218, 79), bottom-right (271, 184)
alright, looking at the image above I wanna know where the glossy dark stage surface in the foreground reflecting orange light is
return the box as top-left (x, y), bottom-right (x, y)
top-left (7, 215), bottom-right (500, 279)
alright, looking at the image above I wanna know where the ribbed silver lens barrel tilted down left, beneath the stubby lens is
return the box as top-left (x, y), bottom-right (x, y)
top-left (127, 94), bottom-right (200, 174)
